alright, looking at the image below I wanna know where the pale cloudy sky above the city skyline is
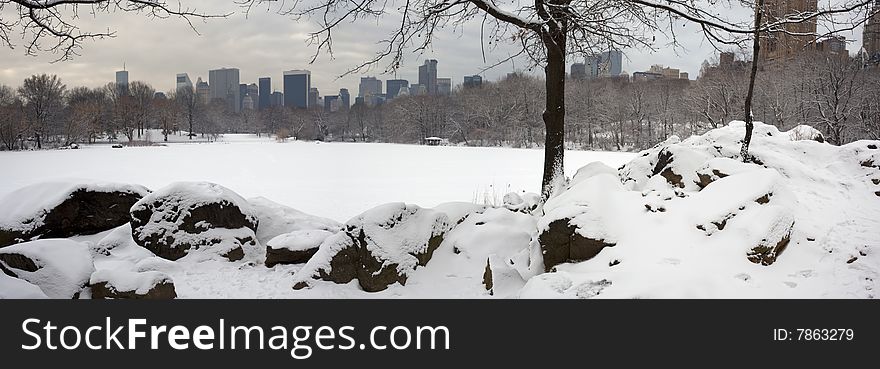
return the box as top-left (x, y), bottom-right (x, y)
top-left (0, 0), bottom-right (861, 95)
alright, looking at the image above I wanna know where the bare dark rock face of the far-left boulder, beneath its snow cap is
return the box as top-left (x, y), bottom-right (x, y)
top-left (0, 189), bottom-right (142, 247)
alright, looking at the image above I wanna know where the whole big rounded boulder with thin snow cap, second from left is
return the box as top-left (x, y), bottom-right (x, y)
top-left (131, 182), bottom-right (259, 261)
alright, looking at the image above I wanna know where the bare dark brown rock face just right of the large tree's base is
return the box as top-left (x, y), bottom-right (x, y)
top-left (538, 219), bottom-right (615, 272)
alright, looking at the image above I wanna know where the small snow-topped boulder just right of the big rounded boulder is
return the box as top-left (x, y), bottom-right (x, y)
top-left (266, 229), bottom-right (333, 268)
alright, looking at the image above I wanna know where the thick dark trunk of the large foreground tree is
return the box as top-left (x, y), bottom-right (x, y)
top-left (541, 27), bottom-right (566, 200)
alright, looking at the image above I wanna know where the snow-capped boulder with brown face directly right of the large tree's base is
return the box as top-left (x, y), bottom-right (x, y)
top-left (538, 173), bottom-right (623, 271)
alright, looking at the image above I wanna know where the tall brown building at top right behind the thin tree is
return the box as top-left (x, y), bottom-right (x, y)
top-left (758, 0), bottom-right (818, 64)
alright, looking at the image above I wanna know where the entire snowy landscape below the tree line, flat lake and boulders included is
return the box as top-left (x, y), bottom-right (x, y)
top-left (0, 122), bottom-right (880, 298)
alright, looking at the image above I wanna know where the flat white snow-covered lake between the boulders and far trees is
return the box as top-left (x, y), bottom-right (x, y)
top-left (0, 135), bottom-right (635, 222)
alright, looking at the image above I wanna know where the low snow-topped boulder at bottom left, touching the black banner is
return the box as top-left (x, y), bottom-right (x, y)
top-left (89, 269), bottom-right (177, 299)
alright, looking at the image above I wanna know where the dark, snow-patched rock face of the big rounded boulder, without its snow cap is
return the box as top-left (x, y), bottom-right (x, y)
top-left (130, 188), bottom-right (257, 261)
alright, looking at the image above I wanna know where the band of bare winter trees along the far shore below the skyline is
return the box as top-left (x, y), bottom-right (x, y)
top-left (0, 54), bottom-right (880, 151)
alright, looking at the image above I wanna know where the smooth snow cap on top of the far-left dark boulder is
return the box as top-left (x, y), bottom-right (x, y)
top-left (0, 179), bottom-right (149, 231)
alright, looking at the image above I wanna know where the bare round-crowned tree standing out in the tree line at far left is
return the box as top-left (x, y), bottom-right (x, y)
top-left (18, 74), bottom-right (67, 149)
